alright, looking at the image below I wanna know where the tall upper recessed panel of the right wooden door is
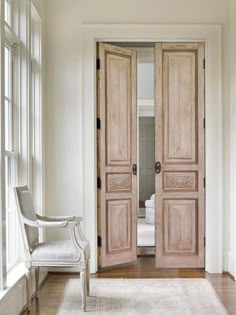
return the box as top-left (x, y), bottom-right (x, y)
top-left (163, 50), bottom-right (197, 164)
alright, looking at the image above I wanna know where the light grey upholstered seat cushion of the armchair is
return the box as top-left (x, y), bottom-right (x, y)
top-left (31, 240), bottom-right (80, 262)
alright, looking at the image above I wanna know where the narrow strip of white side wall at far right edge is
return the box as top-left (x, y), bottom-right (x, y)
top-left (224, 0), bottom-right (236, 278)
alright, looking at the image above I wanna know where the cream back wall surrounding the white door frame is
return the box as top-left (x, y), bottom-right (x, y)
top-left (45, 0), bottom-right (235, 270)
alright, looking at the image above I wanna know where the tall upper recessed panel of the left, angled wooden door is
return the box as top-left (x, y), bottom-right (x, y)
top-left (105, 53), bottom-right (132, 166)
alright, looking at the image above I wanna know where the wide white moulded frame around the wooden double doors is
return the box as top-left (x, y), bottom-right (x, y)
top-left (82, 24), bottom-right (223, 273)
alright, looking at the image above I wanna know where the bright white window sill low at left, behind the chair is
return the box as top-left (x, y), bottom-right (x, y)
top-left (0, 262), bottom-right (25, 301)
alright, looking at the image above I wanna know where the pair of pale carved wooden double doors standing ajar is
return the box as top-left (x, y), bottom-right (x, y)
top-left (97, 43), bottom-right (205, 268)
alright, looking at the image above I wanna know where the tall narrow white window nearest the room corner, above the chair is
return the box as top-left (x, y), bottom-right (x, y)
top-left (29, 3), bottom-right (43, 220)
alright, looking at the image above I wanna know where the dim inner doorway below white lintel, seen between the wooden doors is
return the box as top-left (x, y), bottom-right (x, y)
top-left (137, 116), bottom-right (155, 256)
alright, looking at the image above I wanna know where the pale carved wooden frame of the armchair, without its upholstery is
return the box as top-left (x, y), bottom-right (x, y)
top-left (14, 186), bottom-right (90, 311)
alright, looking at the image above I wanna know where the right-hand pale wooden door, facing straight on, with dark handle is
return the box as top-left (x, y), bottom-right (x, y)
top-left (155, 43), bottom-right (205, 268)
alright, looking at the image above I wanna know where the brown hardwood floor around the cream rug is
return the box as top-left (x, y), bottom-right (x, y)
top-left (23, 257), bottom-right (236, 315)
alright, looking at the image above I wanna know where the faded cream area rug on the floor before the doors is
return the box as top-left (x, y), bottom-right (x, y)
top-left (57, 279), bottom-right (228, 315)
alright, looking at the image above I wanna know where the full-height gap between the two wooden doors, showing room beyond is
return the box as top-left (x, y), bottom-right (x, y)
top-left (135, 47), bottom-right (155, 257)
